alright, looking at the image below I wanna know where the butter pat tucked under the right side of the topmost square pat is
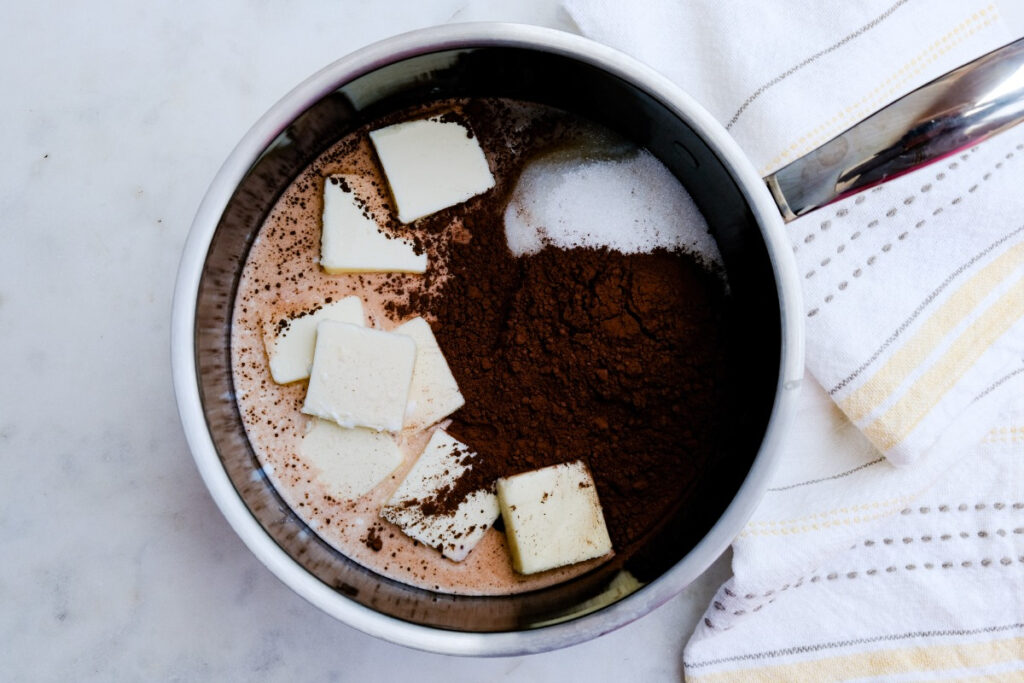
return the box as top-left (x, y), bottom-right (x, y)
top-left (394, 317), bottom-right (466, 429)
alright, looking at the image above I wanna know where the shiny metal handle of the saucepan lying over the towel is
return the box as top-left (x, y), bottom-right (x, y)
top-left (765, 39), bottom-right (1024, 222)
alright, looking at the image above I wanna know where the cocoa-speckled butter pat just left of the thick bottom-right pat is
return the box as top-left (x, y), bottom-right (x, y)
top-left (381, 429), bottom-right (499, 562)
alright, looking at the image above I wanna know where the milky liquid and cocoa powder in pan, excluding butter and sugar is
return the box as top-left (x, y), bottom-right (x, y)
top-left (231, 99), bottom-right (728, 595)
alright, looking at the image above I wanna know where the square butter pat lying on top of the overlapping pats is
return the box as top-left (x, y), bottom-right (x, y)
top-left (302, 321), bottom-right (416, 432)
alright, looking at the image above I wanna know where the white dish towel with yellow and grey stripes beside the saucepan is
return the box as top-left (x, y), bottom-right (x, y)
top-left (564, 0), bottom-right (1024, 681)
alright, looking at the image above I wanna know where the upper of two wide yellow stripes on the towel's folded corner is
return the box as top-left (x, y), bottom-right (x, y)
top-left (839, 243), bottom-right (1024, 422)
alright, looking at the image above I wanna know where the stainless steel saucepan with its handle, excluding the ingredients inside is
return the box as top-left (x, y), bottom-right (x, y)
top-left (172, 24), bottom-right (1024, 654)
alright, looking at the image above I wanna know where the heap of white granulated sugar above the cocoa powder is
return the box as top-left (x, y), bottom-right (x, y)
top-left (505, 150), bottom-right (722, 265)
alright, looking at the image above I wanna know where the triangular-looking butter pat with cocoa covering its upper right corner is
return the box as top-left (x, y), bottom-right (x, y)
top-left (321, 175), bottom-right (427, 273)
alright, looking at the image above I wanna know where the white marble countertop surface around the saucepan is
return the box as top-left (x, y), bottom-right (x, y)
top-left (0, 0), bottom-right (727, 683)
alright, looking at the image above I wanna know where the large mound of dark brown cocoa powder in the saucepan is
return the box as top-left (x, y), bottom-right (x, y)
top-left (390, 98), bottom-right (728, 555)
